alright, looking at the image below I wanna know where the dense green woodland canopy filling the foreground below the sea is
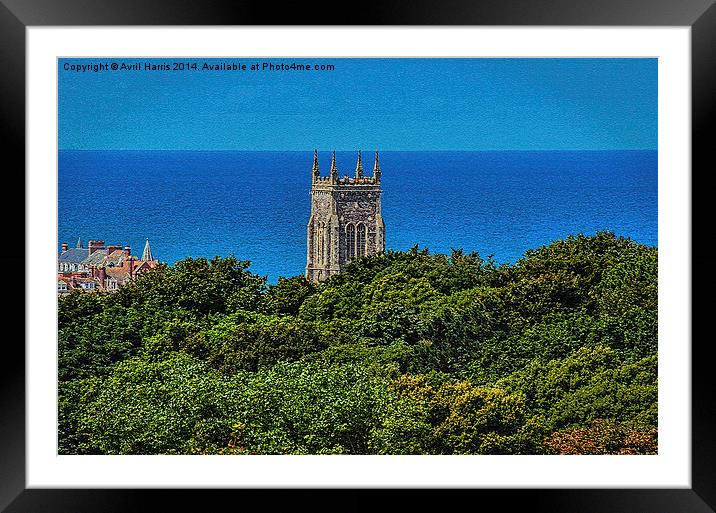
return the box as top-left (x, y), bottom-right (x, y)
top-left (58, 232), bottom-right (657, 454)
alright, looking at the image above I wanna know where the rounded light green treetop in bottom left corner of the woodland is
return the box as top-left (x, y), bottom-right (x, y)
top-left (61, 352), bottom-right (238, 454)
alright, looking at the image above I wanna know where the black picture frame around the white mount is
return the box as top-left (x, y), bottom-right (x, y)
top-left (0, 0), bottom-right (716, 513)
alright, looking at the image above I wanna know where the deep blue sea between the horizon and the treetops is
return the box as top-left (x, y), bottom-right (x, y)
top-left (58, 150), bottom-right (658, 283)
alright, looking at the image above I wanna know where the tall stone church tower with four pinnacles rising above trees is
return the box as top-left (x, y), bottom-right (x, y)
top-left (306, 150), bottom-right (385, 282)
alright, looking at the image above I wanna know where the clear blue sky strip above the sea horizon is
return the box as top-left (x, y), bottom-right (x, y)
top-left (58, 58), bottom-right (657, 151)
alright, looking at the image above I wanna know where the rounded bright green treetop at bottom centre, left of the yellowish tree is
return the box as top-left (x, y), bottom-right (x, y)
top-left (225, 363), bottom-right (389, 454)
